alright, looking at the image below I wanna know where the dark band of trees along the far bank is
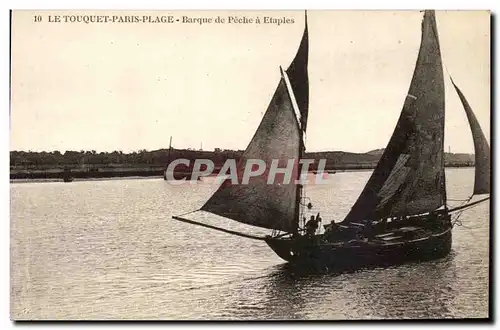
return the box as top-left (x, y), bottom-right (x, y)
top-left (10, 149), bottom-right (474, 170)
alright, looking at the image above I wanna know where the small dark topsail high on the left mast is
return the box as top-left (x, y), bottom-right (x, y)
top-left (286, 14), bottom-right (309, 132)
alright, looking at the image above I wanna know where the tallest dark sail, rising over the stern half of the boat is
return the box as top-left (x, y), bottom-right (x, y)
top-left (344, 11), bottom-right (446, 222)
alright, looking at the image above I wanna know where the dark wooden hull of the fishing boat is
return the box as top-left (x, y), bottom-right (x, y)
top-left (266, 226), bottom-right (452, 270)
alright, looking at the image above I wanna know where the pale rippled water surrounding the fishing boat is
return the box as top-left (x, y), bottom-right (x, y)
top-left (10, 168), bottom-right (490, 320)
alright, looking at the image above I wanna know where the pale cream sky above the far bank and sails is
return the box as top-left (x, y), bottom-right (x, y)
top-left (10, 11), bottom-right (490, 153)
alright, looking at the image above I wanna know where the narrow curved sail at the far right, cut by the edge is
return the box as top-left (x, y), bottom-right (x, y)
top-left (451, 79), bottom-right (491, 195)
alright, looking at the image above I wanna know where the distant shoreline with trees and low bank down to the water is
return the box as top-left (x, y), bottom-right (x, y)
top-left (10, 149), bottom-right (474, 180)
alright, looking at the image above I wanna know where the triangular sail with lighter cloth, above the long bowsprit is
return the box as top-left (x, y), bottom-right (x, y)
top-left (201, 77), bottom-right (300, 232)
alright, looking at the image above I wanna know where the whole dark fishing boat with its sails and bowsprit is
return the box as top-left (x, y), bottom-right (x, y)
top-left (173, 11), bottom-right (490, 268)
